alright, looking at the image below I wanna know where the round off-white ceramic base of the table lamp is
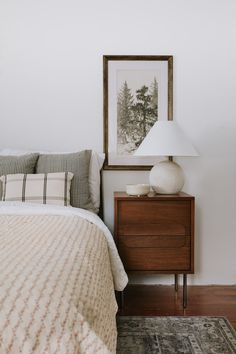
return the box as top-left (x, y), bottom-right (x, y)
top-left (149, 160), bottom-right (184, 194)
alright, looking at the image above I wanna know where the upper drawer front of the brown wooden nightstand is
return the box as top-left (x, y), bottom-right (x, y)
top-left (117, 201), bottom-right (191, 236)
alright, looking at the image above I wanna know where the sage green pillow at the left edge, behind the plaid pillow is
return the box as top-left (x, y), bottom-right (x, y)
top-left (0, 154), bottom-right (39, 200)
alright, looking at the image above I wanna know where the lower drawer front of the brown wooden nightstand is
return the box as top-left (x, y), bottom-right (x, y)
top-left (118, 236), bottom-right (191, 271)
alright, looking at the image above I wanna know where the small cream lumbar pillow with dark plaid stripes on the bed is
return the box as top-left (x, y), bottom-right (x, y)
top-left (0, 172), bottom-right (73, 206)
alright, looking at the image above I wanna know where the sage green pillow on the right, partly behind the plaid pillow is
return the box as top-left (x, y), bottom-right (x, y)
top-left (36, 150), bottom-right (94, 211)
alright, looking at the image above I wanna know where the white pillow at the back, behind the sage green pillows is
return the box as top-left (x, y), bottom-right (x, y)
top-left (0, 149), bottom-right (105, 213)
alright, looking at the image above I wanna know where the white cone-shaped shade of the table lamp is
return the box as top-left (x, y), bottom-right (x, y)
top-left (134, 121), bottom-right (198, 156)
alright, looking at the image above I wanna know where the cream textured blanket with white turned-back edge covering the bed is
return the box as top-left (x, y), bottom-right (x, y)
top-left (0, 203), bottom-right (127, 354)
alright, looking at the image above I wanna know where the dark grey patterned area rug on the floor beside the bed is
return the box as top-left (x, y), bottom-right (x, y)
top-left (117, 316), bottom-right (236, 354)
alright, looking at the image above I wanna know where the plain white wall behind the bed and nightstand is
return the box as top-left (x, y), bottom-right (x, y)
top-left (0, 0), bottom-right (236, 284)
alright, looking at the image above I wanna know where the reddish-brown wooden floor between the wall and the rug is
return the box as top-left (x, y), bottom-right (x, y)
top-left (119, 285), bottom-right (236, 329)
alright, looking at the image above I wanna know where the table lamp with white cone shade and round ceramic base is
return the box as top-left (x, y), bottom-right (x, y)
top-left (134, 121), bottom-right (198, 194)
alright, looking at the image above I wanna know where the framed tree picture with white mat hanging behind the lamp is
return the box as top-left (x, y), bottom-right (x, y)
top-left (103, 55), bottom-right (173, 170)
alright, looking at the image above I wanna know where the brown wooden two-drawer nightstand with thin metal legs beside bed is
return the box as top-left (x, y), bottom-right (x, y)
top-left (114, 192), bottom-right (194, 308)
